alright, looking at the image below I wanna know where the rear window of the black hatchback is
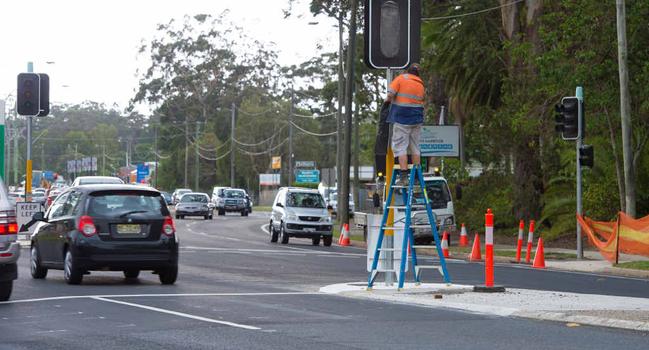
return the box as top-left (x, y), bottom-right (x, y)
top-left (88, 191), bottom-right (169, 217)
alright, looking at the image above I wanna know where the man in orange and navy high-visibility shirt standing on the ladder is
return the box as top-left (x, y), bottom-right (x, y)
top-left (386, 63), bottom-right (425, 186)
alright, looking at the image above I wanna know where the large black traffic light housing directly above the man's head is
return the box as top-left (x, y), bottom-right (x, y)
top-left (363, 0), bottom-right (421, 69)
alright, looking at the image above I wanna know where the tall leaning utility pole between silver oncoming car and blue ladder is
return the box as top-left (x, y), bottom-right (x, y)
top-left (338, 0), bottom-right (358, 224)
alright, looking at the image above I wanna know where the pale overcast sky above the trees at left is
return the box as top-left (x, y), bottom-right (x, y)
top-left (0, 0), bottom-right (338, 109)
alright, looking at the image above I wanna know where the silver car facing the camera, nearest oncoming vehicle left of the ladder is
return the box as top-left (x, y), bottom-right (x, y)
top-left (269, 187), bottom-right (333, 247)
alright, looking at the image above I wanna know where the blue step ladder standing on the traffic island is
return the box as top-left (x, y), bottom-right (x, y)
top-left (367, 165), bottom-right (451, 290)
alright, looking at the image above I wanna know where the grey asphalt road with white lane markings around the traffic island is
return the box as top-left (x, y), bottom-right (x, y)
top-left (0, 213), bottom-right (649, 349)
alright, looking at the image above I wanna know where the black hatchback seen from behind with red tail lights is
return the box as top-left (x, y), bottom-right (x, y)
top-left (30, 185), bottom-right (178, 284)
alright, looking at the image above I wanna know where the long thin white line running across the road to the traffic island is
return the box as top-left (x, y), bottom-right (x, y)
top-left (0, 292), bottom-right (322, 305)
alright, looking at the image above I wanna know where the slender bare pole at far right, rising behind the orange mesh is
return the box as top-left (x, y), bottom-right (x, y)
top-left (615, 0), bottom-right (636, 218)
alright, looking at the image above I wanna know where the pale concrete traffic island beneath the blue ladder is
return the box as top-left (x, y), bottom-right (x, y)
top-left (320, 282), bottom-right (649, 332)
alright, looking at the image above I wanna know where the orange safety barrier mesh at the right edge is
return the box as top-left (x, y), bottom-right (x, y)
top-left (577, 212), bottom-right (649, 263)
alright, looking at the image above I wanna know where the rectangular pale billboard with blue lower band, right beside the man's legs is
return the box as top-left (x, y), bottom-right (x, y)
top-left (419, 125), bottom-right (460, 157)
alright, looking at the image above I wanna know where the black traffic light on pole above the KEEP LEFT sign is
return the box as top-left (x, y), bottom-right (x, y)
top-left (16, 73), bottom-right (50, 117)
